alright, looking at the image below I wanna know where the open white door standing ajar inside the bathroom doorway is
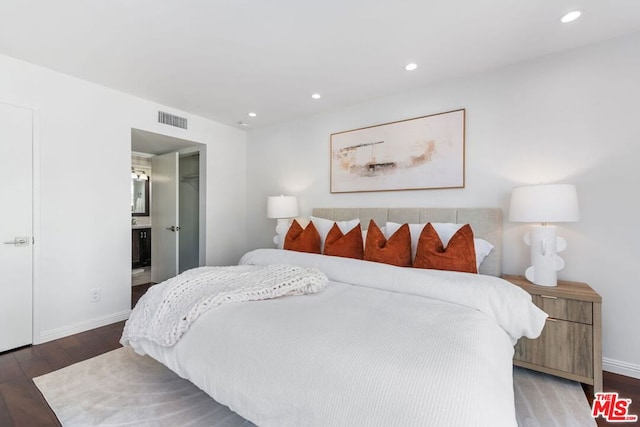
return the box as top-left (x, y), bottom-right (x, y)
top-left (150, 153), bottom-right (180, 283)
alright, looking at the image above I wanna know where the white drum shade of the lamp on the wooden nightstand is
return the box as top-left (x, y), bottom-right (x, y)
top-left (509, 184), bottom-right (580, 223)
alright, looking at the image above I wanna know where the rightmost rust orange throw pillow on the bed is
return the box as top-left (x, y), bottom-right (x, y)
top-left (413, 224), bottom-right (478, 273)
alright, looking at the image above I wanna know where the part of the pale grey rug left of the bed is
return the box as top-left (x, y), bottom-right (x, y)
top-left (33, 347), bottom-right (254, 427)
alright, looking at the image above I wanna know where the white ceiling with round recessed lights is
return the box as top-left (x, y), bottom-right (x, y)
top-left (0, 0), bottom-right (640, 129)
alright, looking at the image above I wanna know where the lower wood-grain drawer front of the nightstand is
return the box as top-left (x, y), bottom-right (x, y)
top-left (514, 319), bottom-right (593, 378)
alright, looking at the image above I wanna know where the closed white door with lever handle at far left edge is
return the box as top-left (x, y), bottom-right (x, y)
top-left (0, 103), bottom-right (33, 352)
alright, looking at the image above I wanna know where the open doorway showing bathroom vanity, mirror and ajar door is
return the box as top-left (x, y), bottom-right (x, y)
top-left (131, 129), bottom-right (206, 286)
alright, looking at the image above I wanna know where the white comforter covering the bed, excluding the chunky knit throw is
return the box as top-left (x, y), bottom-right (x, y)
top-left (130, 249), bottom-right (546, 427)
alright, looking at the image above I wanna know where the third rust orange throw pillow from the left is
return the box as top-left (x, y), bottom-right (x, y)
top-left (364, 220), bottom-right (411, 267)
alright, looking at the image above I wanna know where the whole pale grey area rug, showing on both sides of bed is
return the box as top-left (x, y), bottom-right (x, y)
top-left (33, 348), bottom-right (596, 427)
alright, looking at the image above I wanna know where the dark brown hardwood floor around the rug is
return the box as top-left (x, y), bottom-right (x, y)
top-left (0, 284), bottom-right (640, 427)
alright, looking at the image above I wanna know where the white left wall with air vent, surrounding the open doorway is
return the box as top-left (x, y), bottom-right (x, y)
top-left (0, 52), bottom-right (246, 343)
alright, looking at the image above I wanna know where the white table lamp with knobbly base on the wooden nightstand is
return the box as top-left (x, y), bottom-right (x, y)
top-left (509, 184), bottom-right (580, 286)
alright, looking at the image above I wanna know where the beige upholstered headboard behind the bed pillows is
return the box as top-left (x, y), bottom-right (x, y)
top-left (312, 208), bottom-right (502, 276)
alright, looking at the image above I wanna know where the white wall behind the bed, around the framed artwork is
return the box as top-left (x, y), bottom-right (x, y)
top-left (247, 33), bottom-right (640, 377)
